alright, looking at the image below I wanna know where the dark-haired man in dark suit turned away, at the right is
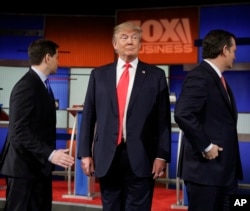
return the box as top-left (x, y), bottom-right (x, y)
top-left (174, 30), bottom-right (243, 211)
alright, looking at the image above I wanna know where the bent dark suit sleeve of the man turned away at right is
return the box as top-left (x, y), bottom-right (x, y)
top-left (174, 72), bottom-right (211, 152)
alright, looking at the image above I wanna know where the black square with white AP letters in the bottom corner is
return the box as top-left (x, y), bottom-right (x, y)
top-left (230, 194), bottom-right (250, 211)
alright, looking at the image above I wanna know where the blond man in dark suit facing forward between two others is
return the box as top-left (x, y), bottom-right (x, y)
top-left (78, 22), bottom-right (171, 211)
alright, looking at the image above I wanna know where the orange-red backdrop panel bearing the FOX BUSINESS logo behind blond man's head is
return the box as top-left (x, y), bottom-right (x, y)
top-left (117, 7), bottom-right (199, 65)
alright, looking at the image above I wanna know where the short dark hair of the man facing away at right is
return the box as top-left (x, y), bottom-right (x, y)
top-left (202, 29), bottom-right (236, 59)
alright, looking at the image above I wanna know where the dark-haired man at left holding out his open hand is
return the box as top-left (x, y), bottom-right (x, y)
top-left (0, 39), bottom-right (74, 211)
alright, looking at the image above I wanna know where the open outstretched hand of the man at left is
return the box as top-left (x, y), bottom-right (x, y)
top-left (51, 149), bottom-right (75, 168)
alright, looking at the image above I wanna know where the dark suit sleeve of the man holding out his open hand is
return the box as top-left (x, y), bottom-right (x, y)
top-left (9, 77), bottom-right (54, 163)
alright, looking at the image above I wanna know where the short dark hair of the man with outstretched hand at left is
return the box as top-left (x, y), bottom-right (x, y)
top-left (28, 39), bottom-right (59, 65)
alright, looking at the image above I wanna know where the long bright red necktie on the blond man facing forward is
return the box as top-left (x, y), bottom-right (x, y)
top-left (117, 63), bottom-right (131, 145)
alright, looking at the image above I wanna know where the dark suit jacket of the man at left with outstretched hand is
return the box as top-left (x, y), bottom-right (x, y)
top-left (0, 69), bottom-right (56, 178)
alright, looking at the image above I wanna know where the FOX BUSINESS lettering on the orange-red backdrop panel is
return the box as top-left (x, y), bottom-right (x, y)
top-left (133, 18), bottom-right (193, 54)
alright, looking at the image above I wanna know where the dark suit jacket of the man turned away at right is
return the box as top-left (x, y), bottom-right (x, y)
top-left (174, 61), bottom-right (242, 186)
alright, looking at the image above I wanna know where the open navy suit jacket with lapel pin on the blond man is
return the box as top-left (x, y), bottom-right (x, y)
top-left (78, 61), bottom-right (171, 177)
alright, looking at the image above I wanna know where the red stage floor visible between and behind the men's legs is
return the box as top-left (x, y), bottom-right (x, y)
top-left (0, 179), bottom-right (187, 211)
